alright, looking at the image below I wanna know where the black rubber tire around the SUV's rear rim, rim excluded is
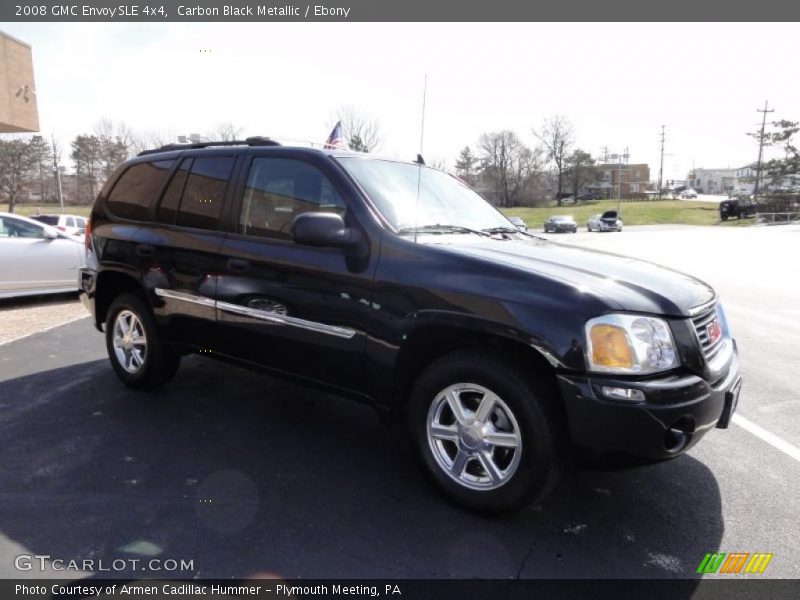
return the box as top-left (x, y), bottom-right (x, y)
top-left (105, 294), bottom-right (181, 389)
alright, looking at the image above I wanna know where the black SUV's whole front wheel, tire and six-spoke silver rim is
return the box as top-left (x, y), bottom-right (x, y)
top-left (409, 349), bottom-right (562, 513)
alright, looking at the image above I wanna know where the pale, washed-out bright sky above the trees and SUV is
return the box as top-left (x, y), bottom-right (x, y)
top-left (0, 23), bottom-right (800, 180)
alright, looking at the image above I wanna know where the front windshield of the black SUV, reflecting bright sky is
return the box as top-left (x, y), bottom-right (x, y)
top-left (339, 157), bottom-right (514, 230)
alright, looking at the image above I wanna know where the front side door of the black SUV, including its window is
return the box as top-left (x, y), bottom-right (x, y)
top-left (212, 151), bottom-right (376, 392)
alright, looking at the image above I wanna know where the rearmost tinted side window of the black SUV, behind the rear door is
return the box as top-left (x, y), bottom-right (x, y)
top-left (107, 160), bottom-right (173, 221)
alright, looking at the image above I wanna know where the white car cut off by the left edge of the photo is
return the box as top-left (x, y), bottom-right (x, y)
top-left (0, 212), bottom-right (86, 298)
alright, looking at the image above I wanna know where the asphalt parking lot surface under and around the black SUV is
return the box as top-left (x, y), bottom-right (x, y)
top-left (0, 223), bottom-right (800, 578)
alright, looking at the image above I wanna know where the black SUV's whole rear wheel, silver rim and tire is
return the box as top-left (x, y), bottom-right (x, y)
top-left (105, 294), bottom-right (180, 389)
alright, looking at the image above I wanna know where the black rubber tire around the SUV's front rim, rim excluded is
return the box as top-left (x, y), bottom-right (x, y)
top-left (408, 349), bottom-right (565, 514)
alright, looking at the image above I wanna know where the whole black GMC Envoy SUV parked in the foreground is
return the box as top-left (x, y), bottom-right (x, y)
top-left (81, 138), bottom-right (741, 512)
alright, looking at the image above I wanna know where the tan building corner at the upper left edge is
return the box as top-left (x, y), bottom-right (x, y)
top-left (0, 31), bottom-right (39, 133)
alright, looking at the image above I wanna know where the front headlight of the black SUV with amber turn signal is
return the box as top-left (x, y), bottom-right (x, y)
top-left (586, 314), bottom-right (680, 375)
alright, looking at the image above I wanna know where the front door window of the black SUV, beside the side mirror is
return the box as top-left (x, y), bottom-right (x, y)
top-left (238, 158), bottom-right (345, 240)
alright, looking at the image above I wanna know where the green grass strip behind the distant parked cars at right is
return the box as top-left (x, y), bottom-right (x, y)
top-left (501, 200), bottom-right (755, 229)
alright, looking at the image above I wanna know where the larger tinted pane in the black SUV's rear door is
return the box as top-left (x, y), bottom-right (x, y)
top-left (178, 156), bottom-right (234, 229)
